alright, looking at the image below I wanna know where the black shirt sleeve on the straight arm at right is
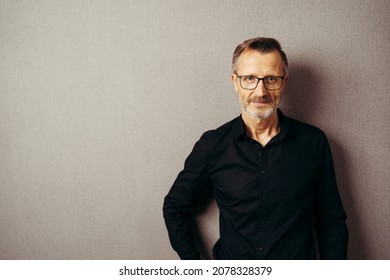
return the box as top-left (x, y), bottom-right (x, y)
top-left (316, 136), bottom-right (348, 260)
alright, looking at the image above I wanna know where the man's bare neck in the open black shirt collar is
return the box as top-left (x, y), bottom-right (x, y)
top-left (242, 110), bottom-right (279, 146)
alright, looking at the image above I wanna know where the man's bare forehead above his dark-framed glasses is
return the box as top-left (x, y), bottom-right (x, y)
top-left (237, 50), bottom-right (283, 75)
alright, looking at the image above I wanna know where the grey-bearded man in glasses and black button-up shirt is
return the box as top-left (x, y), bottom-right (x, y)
top-left (163, 38), bottom-right (348, 259)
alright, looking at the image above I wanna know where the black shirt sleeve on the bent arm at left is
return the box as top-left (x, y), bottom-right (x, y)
top-left (163, 136), bottom-right (208, 259)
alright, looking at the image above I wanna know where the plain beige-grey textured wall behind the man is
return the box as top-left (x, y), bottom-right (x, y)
top-left (0, 0), bottom-right (390, 259)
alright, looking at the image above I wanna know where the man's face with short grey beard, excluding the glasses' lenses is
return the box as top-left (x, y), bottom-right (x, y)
top-left (231, 50), bottom-right (288, 119)
